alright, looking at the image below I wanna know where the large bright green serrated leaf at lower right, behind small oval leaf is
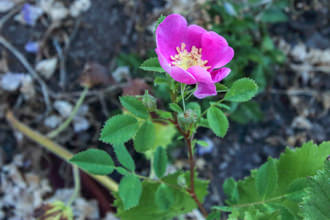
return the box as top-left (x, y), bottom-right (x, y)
top-left (229, 142), bottom-right (330, 220)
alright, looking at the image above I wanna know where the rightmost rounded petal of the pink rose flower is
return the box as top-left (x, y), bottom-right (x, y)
top-left (202, 31), bottom-right (234, 70)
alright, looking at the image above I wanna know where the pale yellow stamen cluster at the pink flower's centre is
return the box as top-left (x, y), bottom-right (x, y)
top-left (171, 43), bottom-right (209, 70)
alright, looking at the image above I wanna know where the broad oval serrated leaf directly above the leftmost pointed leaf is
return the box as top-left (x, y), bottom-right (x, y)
top-left (100, 115), bottom-right (138, 144)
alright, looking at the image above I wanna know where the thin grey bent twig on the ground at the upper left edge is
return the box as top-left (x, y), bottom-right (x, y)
top-left (0, 36), bottom-right (51, 114)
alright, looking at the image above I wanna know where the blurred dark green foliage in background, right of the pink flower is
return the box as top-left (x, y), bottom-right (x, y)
top-left (208, 0), bottom-right (289, 123)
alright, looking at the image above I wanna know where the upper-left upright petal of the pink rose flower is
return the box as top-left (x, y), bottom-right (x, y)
top-left (156, 14), bottom-right (187, 62)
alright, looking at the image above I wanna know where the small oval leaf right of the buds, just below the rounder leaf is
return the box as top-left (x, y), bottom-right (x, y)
top-left (207, 107), bottom-right (229, 137)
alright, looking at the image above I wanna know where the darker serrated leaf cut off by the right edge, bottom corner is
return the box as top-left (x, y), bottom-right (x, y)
top-left (302, 160), bottom-right (330, 220)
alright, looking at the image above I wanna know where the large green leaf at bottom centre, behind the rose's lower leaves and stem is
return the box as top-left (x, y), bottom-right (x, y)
top-left (115, 172), bottom-right (208, 220)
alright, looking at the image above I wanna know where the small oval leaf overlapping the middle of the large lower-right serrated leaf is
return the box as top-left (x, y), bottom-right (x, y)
top-left (256, 159), bottom-right (278, 198)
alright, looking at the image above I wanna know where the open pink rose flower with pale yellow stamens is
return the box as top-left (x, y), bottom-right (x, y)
top-left (156, 14), bottom-right (234, 99)
